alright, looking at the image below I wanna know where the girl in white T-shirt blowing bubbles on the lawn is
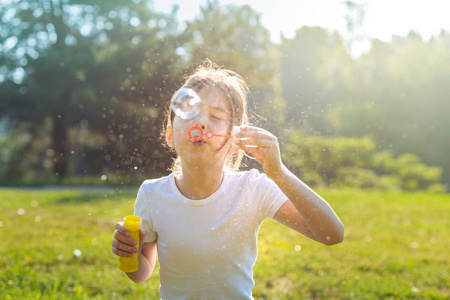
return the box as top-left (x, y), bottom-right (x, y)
top-left (112, 63), bottom-right (344, 299)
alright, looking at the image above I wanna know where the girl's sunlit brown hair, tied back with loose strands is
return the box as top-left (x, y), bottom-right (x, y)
top-left (167, 60), bottom-right (249, 171)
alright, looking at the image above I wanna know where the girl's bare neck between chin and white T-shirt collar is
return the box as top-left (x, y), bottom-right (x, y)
top-left (175, 166), bottom-right (224, 200)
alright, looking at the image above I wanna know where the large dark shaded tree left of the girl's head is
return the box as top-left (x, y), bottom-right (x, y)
top-left (0, 0), bottom-right (185, 178)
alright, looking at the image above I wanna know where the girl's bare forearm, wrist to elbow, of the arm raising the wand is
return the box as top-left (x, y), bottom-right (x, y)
top-left (270, 165), bottom-right (344, 244)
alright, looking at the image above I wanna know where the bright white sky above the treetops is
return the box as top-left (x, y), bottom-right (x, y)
top-left (154, 0), bottom-right (450, 52)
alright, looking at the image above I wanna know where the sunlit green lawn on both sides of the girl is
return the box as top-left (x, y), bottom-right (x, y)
top-left (0, 187), bottom-right (450, 299)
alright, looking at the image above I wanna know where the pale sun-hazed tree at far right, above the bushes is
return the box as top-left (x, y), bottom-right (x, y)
top-left (333, 32), bottom-right (450, 183)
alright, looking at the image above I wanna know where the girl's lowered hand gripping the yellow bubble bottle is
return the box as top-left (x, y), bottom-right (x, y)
top-left (112, 222), bottom-right (145, 257)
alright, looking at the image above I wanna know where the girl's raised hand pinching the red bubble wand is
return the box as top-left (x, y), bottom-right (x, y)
top-left (236, 126), bottom-right (283, 177)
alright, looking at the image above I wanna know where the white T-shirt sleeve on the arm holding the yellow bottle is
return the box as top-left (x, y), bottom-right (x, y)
top-left (134, 182), bottom-right (157, 243)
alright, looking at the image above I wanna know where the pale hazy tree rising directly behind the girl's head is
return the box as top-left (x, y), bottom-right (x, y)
top-left (180, 1), bottom-right (284, 130)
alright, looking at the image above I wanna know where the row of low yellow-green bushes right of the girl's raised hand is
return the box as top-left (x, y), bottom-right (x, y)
top-left (283, 132), bottom-right (445, 192)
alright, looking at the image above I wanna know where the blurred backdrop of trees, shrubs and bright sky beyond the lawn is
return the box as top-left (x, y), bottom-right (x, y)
top-left (0, 0), bottom-right (450, 192)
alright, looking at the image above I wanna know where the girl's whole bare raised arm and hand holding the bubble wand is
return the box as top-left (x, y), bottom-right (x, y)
top-left (236, 126), bottom-right (344, 245)
